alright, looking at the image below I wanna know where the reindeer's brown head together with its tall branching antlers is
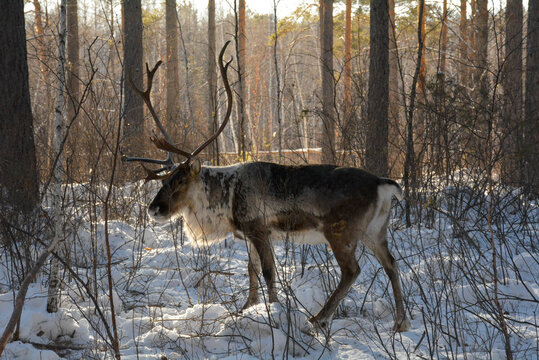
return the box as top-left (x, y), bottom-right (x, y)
top-left (122, 41), bottom-right (232, 221)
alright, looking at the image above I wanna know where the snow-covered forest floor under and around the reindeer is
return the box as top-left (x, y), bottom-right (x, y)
top-left (0, 181), bottom-right (539, 359)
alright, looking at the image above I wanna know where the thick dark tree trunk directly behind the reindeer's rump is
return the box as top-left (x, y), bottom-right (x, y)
top-left (365, 0), bottom-right (389, 176)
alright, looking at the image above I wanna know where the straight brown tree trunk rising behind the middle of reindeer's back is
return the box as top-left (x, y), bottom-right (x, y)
top-left (320, 0), bottom-right (336, 164)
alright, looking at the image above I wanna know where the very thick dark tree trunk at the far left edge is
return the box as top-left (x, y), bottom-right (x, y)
top-left (0, 1), bottom-right (39, 212)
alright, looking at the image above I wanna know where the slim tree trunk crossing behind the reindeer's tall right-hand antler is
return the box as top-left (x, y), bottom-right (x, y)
top-left (207, 0), bottom-right (219, 165)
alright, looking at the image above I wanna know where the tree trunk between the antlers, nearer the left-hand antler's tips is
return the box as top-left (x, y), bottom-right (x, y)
top-left (165, 0), bottom-right (180, 132)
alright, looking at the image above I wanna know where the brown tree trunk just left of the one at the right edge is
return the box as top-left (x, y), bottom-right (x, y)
top-left (500, 0), bottom-right (523, 186)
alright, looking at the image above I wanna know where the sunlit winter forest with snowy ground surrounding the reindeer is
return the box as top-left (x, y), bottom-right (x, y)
top-left (0, 0), bottom-right (539, 360)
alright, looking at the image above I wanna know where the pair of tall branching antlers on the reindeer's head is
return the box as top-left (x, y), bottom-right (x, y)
top-left (122, 40), bottom-right (233, 181)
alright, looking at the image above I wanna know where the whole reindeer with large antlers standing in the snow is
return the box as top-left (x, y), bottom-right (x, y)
top-left (124, 41), bottom-right (410, 331)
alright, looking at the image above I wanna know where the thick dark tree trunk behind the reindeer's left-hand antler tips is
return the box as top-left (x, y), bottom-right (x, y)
top-left (122, 0), bottom-right (144, 154)
